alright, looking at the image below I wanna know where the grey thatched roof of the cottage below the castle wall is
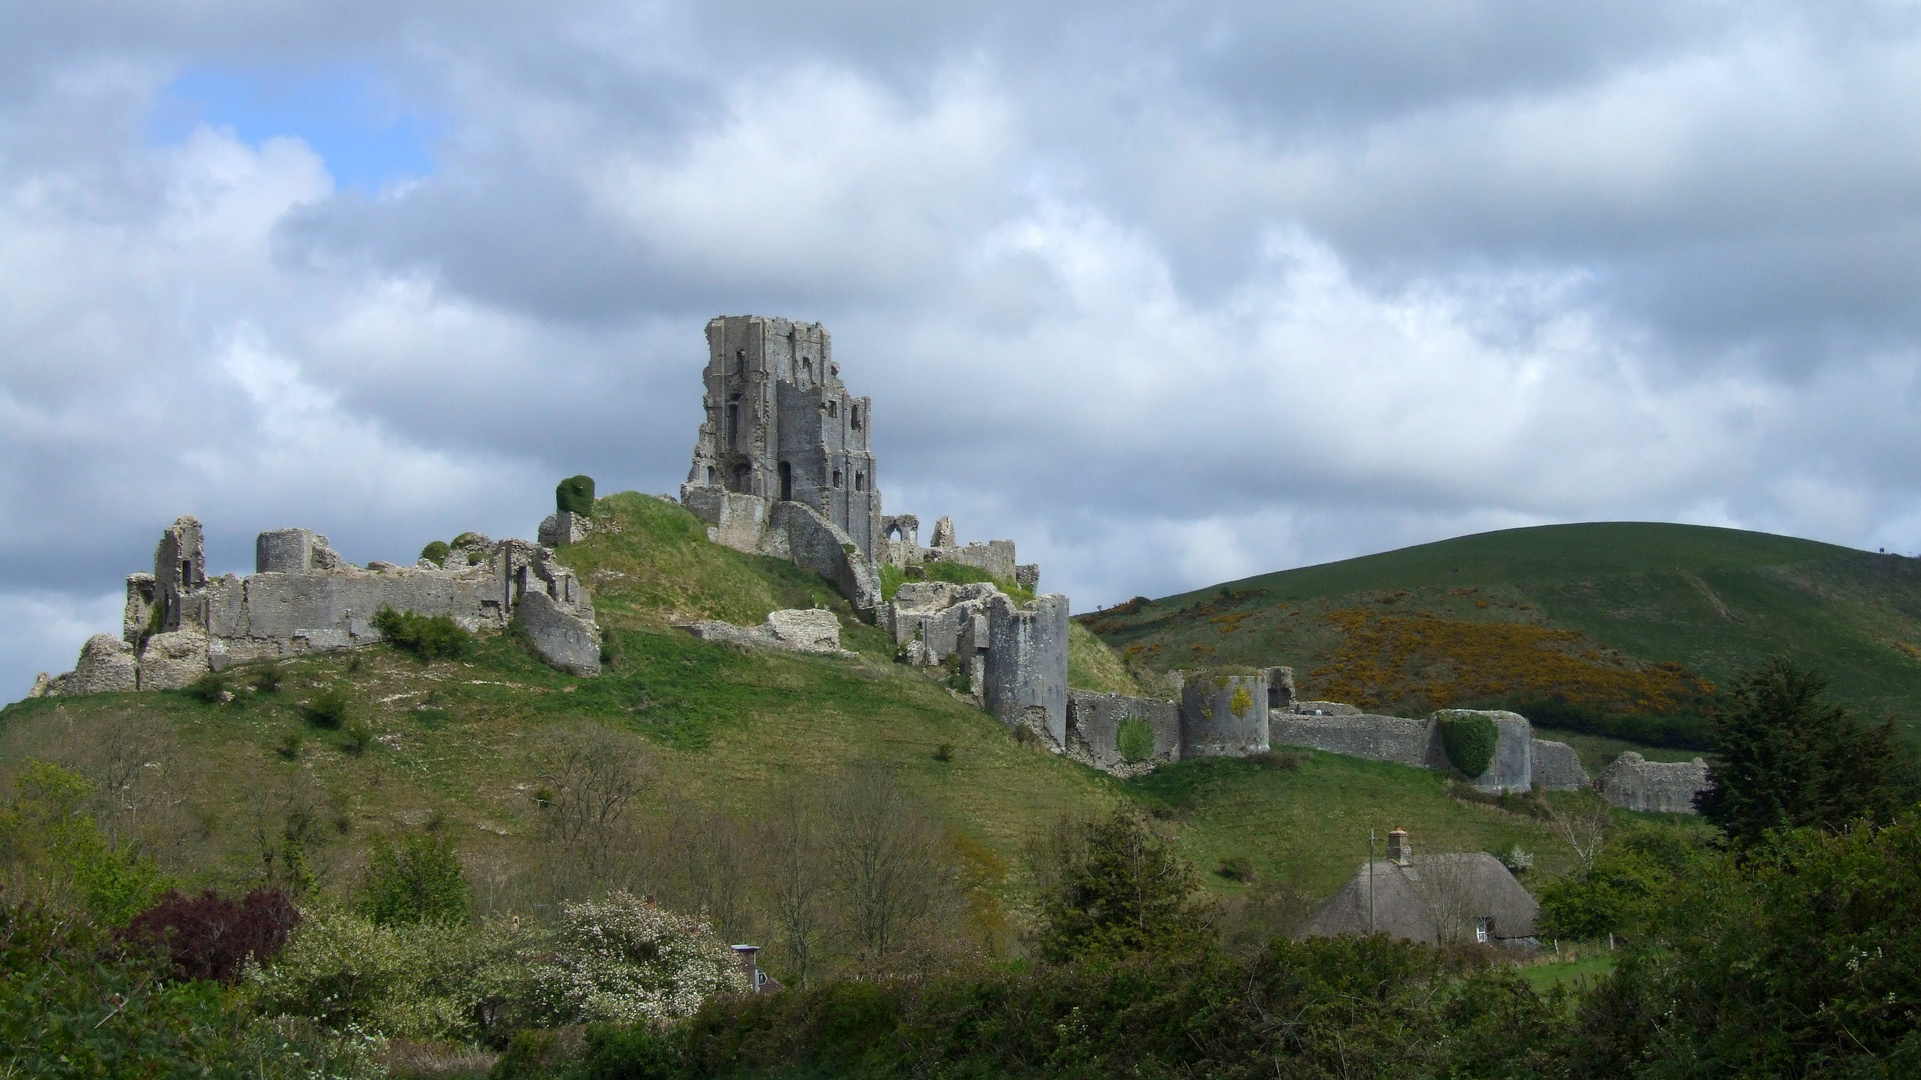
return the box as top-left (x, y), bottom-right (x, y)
top-left (1301, 851), bottom-right (1541, 945)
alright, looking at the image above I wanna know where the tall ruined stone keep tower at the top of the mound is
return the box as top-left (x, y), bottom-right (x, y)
top-left (688, 315), bottom-right (880, 559)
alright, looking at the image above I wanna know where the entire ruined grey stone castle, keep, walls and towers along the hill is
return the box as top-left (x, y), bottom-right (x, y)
top-left (33, 315), bottom-right (1706, 813)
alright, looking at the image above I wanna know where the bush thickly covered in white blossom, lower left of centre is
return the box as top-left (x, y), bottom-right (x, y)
top-left (530, 892), bottom-right (747, 1024)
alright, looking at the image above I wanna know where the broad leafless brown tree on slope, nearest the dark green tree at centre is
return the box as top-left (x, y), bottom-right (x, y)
top-left (828, 769), bottom-right (953, 961)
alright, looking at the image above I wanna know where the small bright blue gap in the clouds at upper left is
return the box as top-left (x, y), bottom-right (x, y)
top-left (148, 65), bottom-right (440, 192)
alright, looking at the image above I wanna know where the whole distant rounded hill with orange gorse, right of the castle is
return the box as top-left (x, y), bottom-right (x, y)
top-left (1080, 523), bottom-right (1921, 732)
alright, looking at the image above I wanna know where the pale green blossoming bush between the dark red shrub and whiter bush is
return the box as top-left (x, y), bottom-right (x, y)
top-left (246, 911), bottom-right (542, 1042)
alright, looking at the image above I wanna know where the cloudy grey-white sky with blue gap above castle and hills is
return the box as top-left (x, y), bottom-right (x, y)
top-left (0, 0), bottom-right (1921, 698)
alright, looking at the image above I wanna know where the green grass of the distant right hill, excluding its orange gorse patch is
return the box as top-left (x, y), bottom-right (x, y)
top-left (1082, 523), bottom-right (1921, 730)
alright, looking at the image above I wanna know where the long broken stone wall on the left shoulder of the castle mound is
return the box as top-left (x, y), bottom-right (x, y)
top-left (46, 517), bottom-right (599, 694)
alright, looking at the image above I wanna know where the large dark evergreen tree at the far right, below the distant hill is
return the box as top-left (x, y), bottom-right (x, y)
top-left (1696, 655), bottom-right (1900, 847)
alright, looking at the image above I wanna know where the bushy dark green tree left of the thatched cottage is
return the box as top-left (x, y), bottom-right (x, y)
top-left (1039, 807), bottom-right (1212, 961)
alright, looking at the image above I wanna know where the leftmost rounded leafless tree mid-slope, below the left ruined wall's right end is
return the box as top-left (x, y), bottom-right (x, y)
top-left (538, 728), bottom-right (644, 880)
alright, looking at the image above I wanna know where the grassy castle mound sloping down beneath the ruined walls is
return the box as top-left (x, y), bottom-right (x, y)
top-left (0, 494), bottom-right (1590, 968)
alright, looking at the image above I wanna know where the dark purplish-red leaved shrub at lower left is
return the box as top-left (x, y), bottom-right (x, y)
top-left (121, 888), bottom-right (300, 984)
